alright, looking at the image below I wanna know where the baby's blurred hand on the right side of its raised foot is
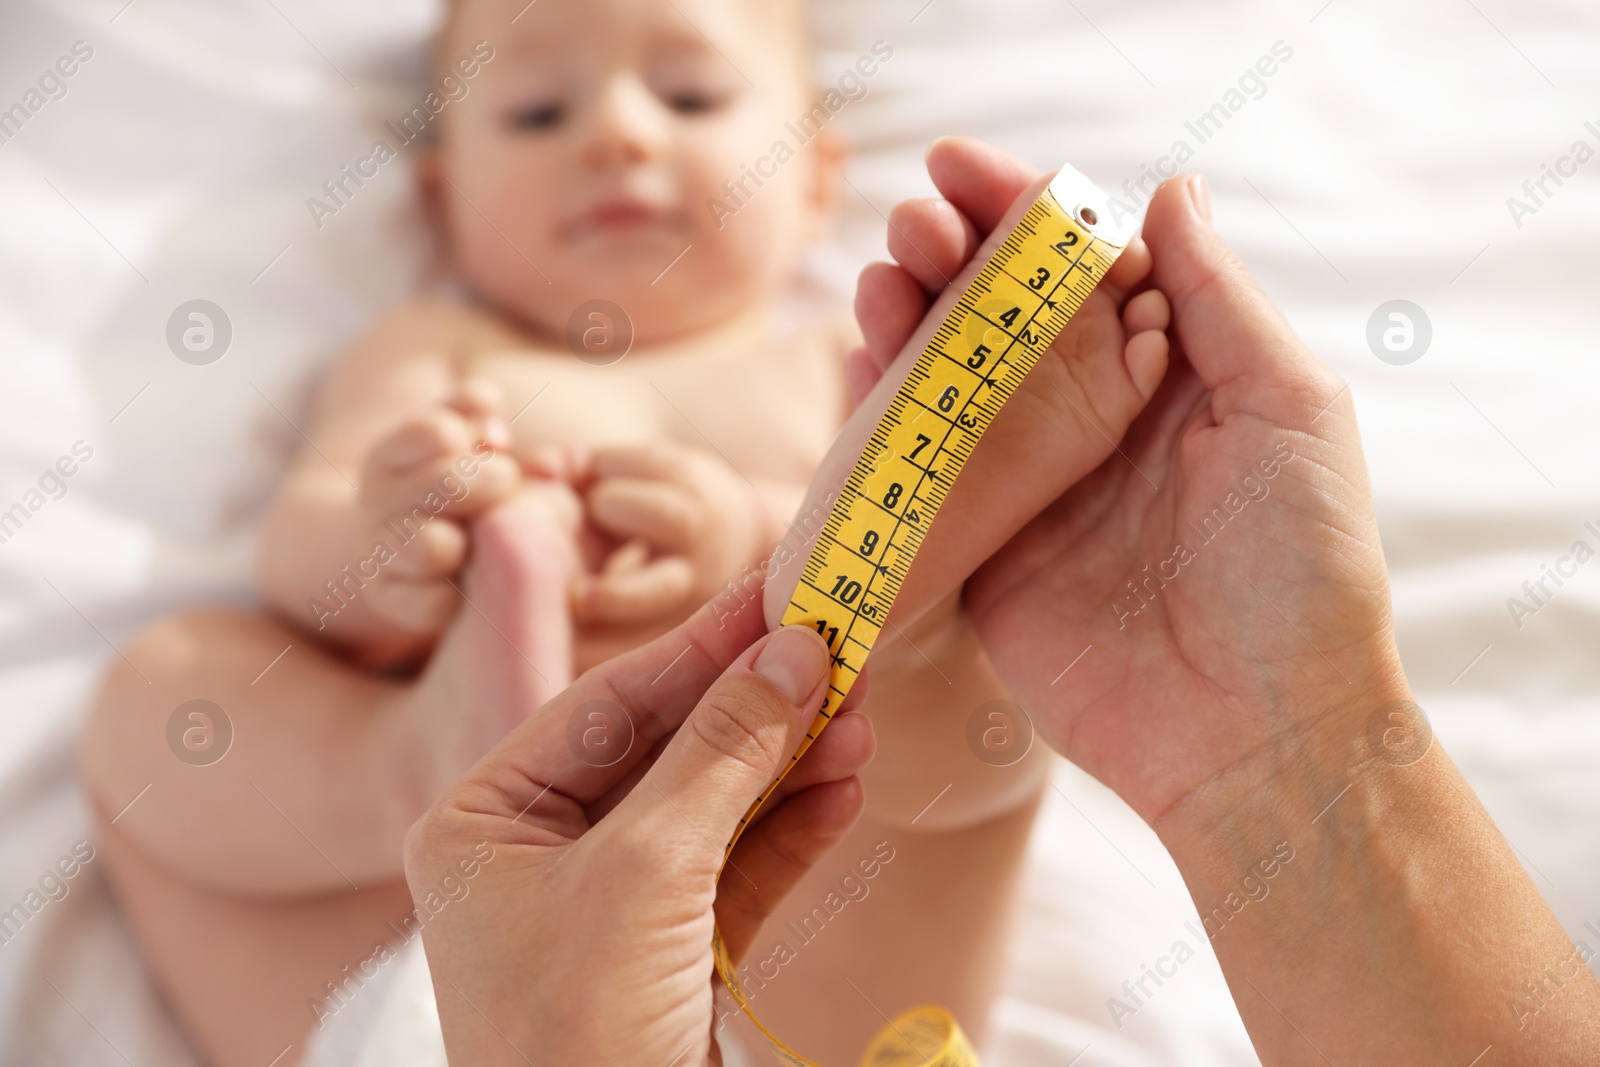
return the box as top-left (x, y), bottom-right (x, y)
top-left (579, 442), bottom-right (776, 624)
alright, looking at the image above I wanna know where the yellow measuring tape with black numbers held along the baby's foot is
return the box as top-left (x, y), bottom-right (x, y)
top-left (712, 166), bottom-right (1133, 1067)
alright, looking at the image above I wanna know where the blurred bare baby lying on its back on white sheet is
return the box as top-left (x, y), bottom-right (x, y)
top-left (83, 0), bottom-right (1164, 1067)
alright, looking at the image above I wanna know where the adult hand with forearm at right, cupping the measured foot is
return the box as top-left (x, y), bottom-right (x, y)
top-left (864, 142), bottom-right (1600, 1064)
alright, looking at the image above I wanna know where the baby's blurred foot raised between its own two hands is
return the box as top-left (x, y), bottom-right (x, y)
top-left (405, 482), bottom-right (579, 787)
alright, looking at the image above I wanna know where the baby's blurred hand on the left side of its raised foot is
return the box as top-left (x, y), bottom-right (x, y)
top-left (358, 379), bottom-right (522, 635)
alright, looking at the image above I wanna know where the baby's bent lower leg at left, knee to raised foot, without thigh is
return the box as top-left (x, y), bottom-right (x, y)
top-left (83, 490), bottom-right (571, 897)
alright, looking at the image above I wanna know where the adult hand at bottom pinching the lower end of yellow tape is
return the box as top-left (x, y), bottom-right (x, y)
top-left (405, 591), bottom-right (872, 1067)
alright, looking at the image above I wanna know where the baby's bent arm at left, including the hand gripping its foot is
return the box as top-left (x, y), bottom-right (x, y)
top-left (259, 306), bottom-right (518, 665)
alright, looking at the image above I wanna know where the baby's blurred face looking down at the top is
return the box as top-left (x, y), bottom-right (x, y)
top-left (435, 0), bottom-right (834, 344)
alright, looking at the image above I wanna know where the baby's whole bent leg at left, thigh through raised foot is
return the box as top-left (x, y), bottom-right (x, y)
top-left (83, 496), bottom-right (571, 1067)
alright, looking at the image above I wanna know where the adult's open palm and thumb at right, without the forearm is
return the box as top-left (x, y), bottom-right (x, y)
top-left (966, 163), bottom-right (1410, 827)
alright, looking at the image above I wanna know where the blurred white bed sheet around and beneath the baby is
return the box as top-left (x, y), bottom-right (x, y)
top-left (0, 0), bottom-right (1600, 1067)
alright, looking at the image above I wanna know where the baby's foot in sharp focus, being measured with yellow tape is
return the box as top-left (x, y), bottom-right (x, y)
top-left (766, 139), bottom-right (1171, 627)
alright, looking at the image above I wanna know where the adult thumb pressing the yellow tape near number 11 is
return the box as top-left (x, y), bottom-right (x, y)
top-left (613, 625), bottom-right (830, 864)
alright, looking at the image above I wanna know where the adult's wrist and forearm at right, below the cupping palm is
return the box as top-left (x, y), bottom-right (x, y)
top-left (1130, 672), bottom-right (1600, 1064)
